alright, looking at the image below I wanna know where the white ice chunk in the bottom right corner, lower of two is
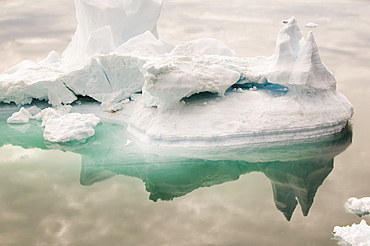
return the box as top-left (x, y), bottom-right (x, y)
top-left (333, 220), bottom-right (370, 246)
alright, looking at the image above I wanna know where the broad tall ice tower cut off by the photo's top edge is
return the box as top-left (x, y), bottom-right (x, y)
top-left (63, 0), bottom-right (162, 59)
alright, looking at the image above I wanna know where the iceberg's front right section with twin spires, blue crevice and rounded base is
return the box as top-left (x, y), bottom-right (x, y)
top-left (128, 18), bottom-right (353, 147)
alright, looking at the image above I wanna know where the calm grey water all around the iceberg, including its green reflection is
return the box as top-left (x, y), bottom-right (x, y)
top-left (0, 0), bottom-right (370, 246)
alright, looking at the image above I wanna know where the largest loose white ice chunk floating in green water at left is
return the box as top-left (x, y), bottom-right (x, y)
top-left (43, 113), bottom-right (100, 142)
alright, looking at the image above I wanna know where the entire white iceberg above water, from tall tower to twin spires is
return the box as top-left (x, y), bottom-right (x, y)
top-left (0, 0), bottom-right (353, 144)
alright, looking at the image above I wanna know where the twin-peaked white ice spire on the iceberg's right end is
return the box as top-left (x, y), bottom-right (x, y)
top-left (266, 17), bottom-right (336, 91)
